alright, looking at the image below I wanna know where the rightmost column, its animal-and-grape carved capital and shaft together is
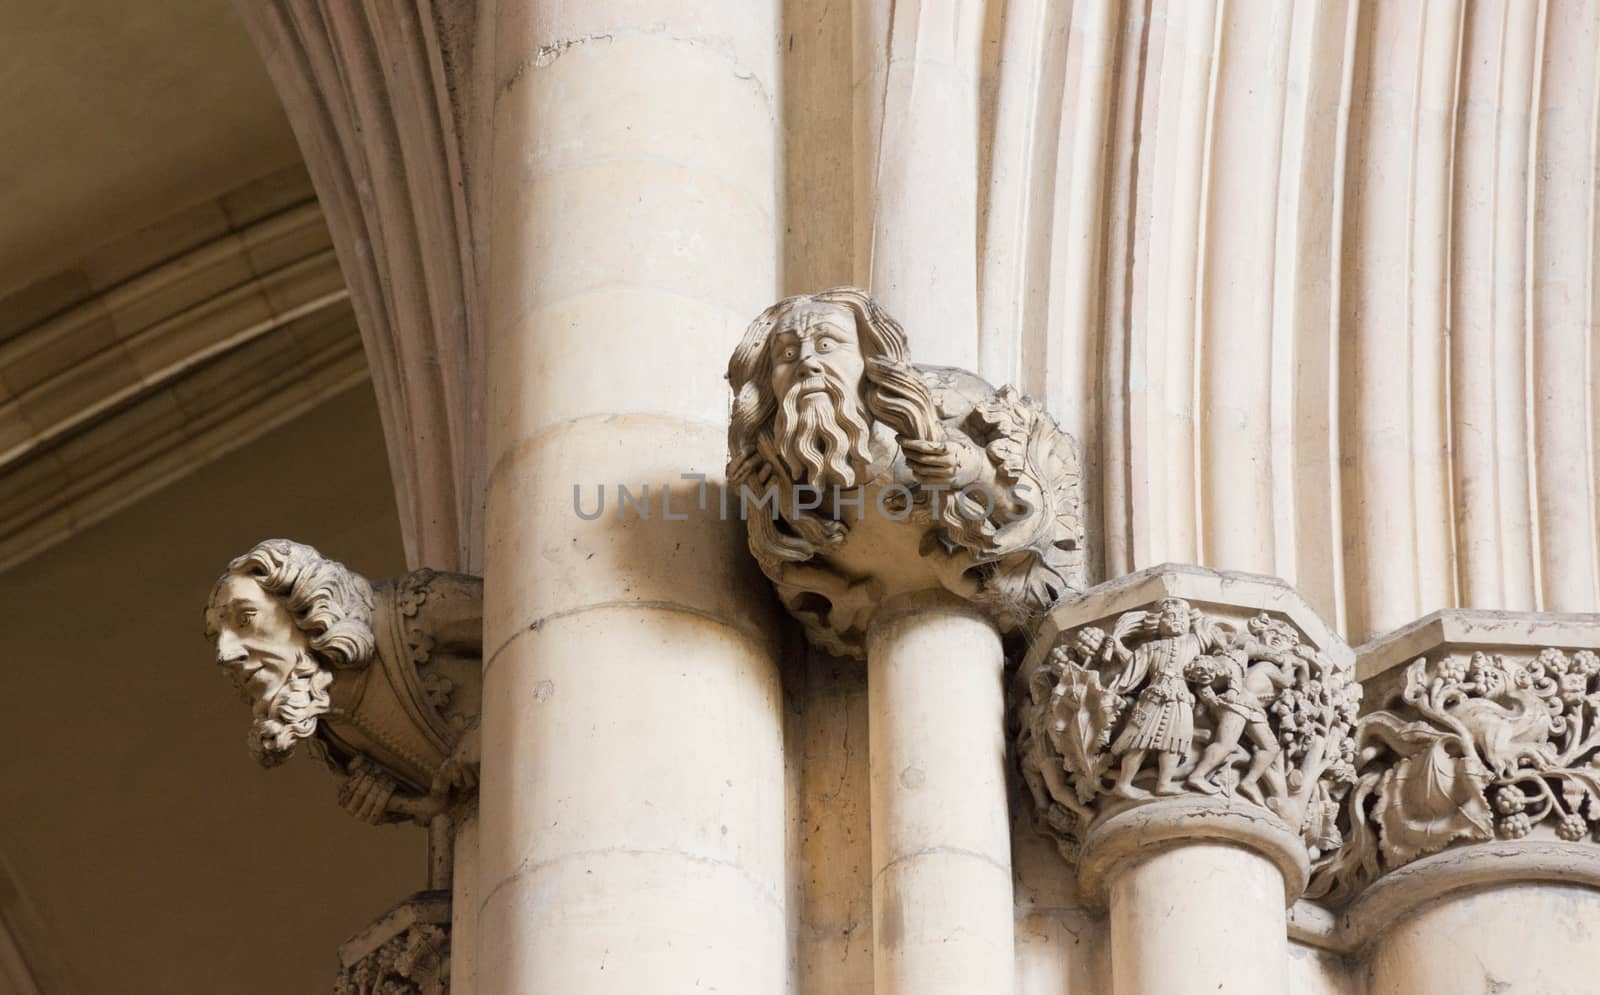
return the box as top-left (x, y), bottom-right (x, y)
top-left (1312, 611), bottom-right (1600, 995)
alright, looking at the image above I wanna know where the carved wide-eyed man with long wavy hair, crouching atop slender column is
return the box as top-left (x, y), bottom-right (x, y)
top-left (728, 288), bottom-right (1083, 656)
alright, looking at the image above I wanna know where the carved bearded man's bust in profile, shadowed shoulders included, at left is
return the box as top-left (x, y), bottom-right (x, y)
top-left (205, 539), bottom-right (483, 822)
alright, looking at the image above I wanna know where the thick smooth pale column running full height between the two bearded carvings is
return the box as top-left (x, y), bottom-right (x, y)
top-left (477, 0), bottom-right (787, 995)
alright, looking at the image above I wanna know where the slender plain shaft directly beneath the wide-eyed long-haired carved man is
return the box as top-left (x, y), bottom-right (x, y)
top-left (867, 595), bottom-right (1014, 995)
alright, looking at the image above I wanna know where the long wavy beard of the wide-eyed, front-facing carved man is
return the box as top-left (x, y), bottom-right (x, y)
top-left (773, 373), bottom-right (872, 491)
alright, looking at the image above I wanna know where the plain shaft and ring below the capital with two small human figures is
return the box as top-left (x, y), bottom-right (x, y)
top-left (1078, 798), bottom-right (1307, 995)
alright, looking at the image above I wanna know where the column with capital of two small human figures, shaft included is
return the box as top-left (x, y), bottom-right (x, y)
top-left (1019, 565), bottom-right (1360, 995)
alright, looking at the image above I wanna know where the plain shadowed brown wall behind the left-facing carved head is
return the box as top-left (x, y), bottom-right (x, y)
top-left (0, 384), bottom-right (426, 995)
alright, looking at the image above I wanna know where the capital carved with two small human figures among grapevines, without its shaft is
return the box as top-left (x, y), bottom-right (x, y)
top-left (1018, 566), bottom-right (1360, 883)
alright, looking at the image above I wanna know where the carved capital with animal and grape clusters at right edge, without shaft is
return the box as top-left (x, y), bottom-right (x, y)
top-left (1309, 611), bottom-right (1600, 904)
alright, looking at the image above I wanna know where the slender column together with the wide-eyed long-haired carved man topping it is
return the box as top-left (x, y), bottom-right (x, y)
top-left (728, 288), bottom-right (1083, 995)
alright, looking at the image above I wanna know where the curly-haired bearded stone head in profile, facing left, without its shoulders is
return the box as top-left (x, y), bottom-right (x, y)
top-left (205, 539), bottom-right (376, 766)
